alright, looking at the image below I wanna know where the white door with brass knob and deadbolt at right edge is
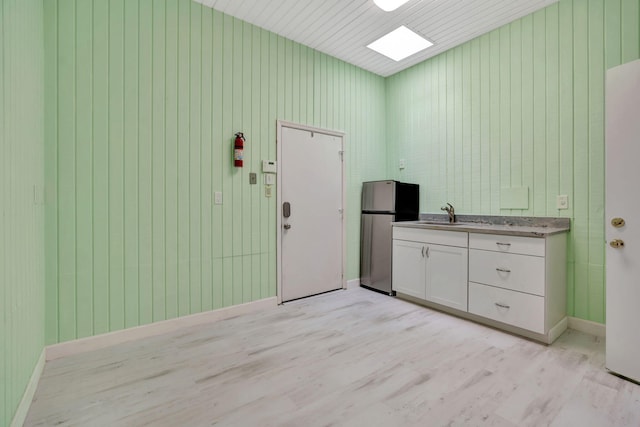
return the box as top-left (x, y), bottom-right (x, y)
top-left (605, 60), bottom-right (640, 381)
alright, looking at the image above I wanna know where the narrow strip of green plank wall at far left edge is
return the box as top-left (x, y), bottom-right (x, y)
top-left (0, 0), bottom-right (45, 426)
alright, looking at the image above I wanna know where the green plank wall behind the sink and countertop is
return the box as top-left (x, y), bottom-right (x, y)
top-left (387, 0), bottom-right (640, 323)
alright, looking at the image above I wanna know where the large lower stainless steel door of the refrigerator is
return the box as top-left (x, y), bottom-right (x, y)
top-left (360, 214), bottom-right (395, 293)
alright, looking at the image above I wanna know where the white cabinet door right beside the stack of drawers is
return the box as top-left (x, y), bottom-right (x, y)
top-left (426, 245), bottom-right (468, 311)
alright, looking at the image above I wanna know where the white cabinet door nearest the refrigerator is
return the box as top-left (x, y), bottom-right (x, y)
top-left (391, 240), bottom-right (426, 299)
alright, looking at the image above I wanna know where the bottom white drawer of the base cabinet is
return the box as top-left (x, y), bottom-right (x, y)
top-left (469, 282), bottom-right (545, 334)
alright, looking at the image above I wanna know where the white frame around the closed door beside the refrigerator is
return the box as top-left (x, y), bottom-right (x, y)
top-left (276, 120), bottom-right (347, 304)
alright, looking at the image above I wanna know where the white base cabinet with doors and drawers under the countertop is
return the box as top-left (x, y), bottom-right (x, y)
top-left (392, 225), bottom-right (567, 343)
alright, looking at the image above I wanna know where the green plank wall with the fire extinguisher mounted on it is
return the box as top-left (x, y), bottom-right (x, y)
top-left (45, 0), bottom-right (386, 343)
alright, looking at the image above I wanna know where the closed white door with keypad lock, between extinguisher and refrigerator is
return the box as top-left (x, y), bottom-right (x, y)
top-left (278, 122), bottom-right (344, 302)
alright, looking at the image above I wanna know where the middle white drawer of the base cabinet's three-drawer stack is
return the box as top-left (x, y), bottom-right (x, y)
top-left (469, 249), bottom-right (545, 296)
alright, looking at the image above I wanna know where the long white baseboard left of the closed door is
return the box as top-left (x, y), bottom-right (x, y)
top-left (46, 297), bottom-right (277, 360)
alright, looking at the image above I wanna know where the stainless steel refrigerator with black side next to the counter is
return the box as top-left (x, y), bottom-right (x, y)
top-left (360, 180), bottom-right (420, 295)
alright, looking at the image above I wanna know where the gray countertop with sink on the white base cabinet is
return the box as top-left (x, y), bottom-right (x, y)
top-left (392, 214), bottom-right (571, 237)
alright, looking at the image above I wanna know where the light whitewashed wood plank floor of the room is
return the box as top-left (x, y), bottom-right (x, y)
top-left (25, 288), bottom-right (640, 427)
